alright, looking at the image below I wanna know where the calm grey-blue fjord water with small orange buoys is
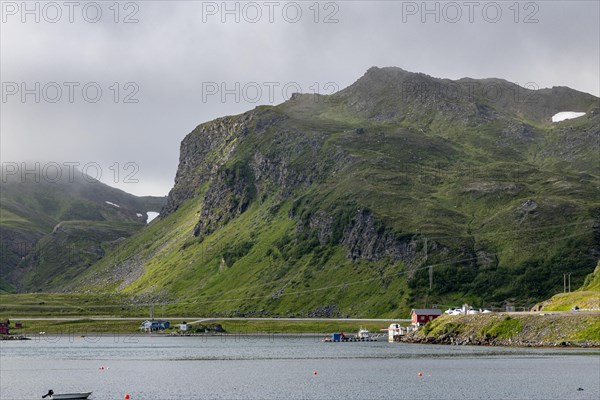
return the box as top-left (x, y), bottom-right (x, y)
top-left (0, 336), bottom-right (600, 400)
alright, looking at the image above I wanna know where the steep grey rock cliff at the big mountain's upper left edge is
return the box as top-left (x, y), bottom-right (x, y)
top-left (161, 104), bottom-right (349, 241)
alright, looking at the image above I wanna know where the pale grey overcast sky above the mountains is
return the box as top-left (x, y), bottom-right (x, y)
top-left (0, 0), bottom-right (600, 195)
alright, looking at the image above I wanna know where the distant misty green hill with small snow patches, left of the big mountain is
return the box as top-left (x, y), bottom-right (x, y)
top-left (0, 168), bottom-right (165, 291)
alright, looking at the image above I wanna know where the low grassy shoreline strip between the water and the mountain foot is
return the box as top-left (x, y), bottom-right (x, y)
top-left (0, 312), bottom-right (600, 349)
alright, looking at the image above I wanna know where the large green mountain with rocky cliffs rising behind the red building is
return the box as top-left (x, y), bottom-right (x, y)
top-left (70, 68), bottom-right (600, 316)
